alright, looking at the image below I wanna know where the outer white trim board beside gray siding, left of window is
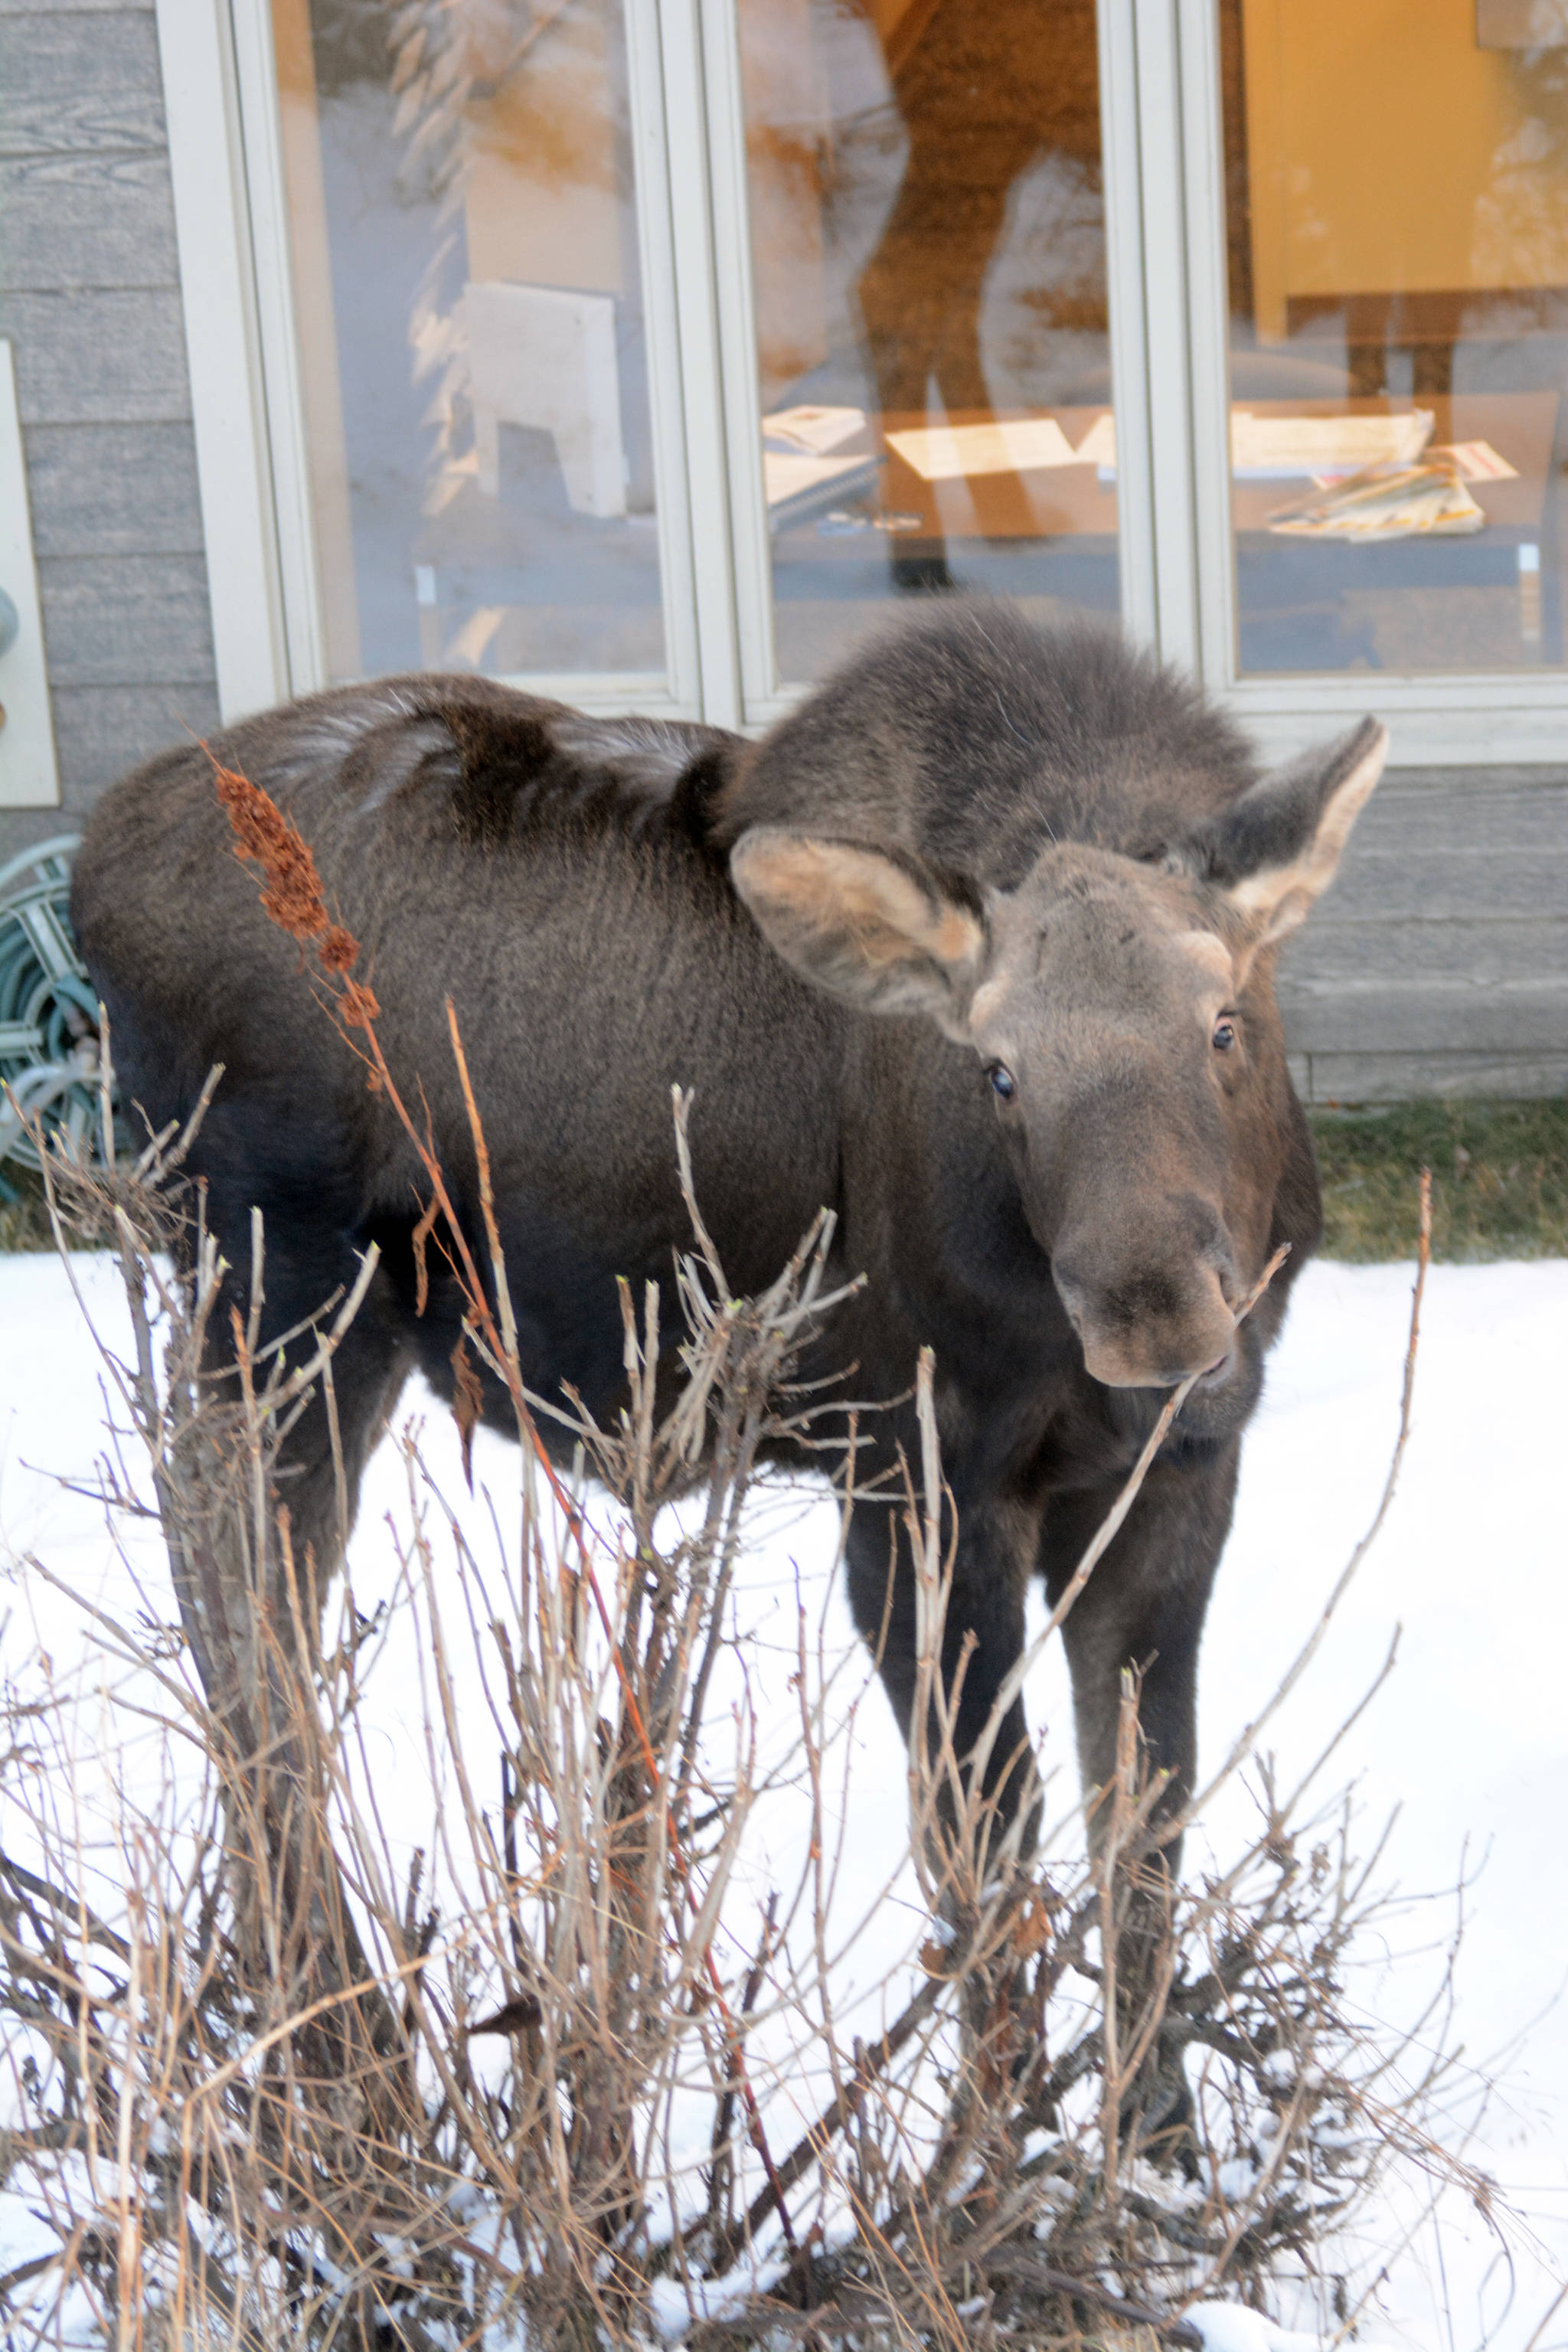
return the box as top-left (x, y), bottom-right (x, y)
top-left (158, 0), bottom-right (289, 720)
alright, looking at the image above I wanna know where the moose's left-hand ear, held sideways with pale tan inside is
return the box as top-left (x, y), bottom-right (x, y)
top-left (729, 825), bottom-right (988, 1042)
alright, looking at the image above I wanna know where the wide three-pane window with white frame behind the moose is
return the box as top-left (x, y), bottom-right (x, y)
top-left (160, 0), bottom-right (1568, 762)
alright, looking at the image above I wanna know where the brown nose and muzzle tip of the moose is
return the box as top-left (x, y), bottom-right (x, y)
top-left (1050, 1204), bottom-right (1236, 1387)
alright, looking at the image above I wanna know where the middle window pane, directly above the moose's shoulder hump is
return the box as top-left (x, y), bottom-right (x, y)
top-left (740, 0), bottom-right (1116, 682)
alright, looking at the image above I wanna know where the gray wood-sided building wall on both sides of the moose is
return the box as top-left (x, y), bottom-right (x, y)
top-left (0, 0), bottom-right (1568, 1101)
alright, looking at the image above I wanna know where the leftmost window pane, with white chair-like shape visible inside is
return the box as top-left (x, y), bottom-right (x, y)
top-left (273, 0), bottom-right (665, 680)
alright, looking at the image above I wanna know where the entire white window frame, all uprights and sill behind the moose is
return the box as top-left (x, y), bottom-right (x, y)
top-left (158, 0), bottom-right (1568, 766)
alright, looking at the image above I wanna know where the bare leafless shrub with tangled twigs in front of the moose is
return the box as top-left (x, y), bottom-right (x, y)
top-left (0, 837), bottom-right (1488, 2352)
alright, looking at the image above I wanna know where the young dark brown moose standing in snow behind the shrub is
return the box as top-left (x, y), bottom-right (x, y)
top-left (73, 605), bottom-right (1387, 1872)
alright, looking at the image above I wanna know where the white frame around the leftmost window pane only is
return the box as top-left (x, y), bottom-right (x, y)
top-left (158, 0), bottom-right (722, 722)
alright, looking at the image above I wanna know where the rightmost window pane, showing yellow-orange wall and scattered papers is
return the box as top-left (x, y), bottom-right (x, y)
top-left (1223, 0), bottom-right (1568, 673)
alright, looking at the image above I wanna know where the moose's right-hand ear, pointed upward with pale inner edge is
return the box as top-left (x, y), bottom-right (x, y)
top-left (1175, 720), bottom-right (1390, 948)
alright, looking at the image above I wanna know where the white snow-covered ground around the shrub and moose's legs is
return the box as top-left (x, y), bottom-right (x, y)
top-left (0, 1259), bottom-right (1568, 2352)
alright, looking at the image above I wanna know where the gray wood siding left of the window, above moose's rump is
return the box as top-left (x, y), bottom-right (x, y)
top-left (0, 0), bottom-right (216, 863)
